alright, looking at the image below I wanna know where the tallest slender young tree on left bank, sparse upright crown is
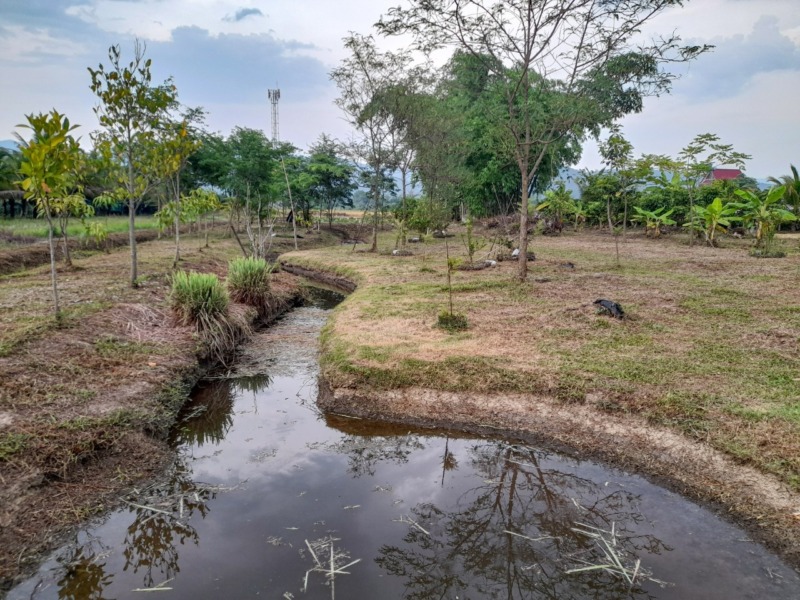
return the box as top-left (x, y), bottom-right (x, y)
top-left (89, 40), bottom-right (177, 287)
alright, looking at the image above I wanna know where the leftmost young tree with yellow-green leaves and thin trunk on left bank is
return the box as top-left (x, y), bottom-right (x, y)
top-left (19, 109), bottom-right (83, 321)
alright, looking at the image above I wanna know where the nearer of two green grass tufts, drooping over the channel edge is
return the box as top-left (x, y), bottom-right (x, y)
top-left (170, 271), bottom-right (250, 364)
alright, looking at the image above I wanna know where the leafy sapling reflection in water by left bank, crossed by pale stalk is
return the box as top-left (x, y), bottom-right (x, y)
top-left (117, 460), bottom-right (217, 588)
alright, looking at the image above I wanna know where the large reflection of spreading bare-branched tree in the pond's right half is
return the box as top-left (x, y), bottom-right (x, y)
top-left (376, 442), bottom-right (664, 600)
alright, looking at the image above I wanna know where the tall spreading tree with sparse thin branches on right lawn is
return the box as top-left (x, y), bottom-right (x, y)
top-left (378, 0), bottom-right (704, 279)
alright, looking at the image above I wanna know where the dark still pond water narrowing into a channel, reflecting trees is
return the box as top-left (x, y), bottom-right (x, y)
top-left (9, 288), bottom-right (800, 600)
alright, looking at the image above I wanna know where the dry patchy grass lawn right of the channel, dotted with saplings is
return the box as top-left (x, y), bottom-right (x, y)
top-left (284, 233), bottom-right (800, 492)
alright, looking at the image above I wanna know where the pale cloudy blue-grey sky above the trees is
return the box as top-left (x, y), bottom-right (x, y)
top-left (0, 0), bottom-right (800, 177)
